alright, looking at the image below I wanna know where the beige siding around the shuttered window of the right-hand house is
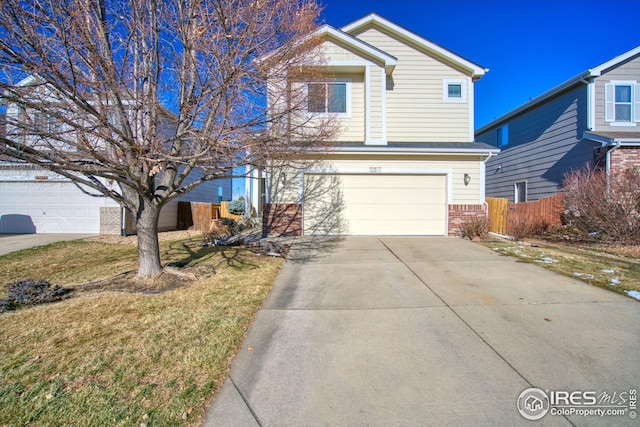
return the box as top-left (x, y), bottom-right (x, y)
top-left (594, 56), bottom-right (640, 132)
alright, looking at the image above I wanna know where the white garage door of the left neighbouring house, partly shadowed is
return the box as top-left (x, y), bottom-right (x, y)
top-left (0, 182), bottom-right (104, 234)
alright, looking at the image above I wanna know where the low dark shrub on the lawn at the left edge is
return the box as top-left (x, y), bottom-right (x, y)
top-left (0, 279), bottom-right (73, 312)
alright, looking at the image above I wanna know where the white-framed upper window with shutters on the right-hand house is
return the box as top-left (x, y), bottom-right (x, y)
top-left (605, 81), bottom-right (640, 126)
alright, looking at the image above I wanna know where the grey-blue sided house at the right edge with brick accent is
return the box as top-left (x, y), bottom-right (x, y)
top-left (476, 46), bottom-right (640, 202)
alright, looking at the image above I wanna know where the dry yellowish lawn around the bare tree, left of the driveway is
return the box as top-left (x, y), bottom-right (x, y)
top-left (0, 238), bottom-right (282, 426)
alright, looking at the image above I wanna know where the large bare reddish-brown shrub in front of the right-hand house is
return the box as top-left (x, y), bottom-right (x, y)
top-left (563, 167), bottom-right (640, 244)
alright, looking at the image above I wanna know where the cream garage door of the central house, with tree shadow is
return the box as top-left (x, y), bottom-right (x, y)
top-left (303, 174), bottom-right (447, 236)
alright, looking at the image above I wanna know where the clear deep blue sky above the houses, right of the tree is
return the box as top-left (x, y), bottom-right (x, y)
top-left (320, 0), bottom-right (640, 128)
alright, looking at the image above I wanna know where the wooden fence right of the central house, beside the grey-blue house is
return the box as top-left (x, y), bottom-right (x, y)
top-left (486, 194), bottom-right (564, 235)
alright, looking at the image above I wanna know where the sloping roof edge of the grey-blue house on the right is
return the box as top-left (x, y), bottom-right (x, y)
top-left (475, 46), bottom-right (640, 135)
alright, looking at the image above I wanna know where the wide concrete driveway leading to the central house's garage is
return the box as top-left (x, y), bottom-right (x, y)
top-left (205, 237), bottom-right (640, 426)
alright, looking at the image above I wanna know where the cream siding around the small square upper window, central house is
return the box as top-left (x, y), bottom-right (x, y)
top-left (356, 28), bottom-right (472, 142)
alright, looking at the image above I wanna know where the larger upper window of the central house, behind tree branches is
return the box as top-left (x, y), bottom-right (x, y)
top-left (307, 81), bottom-right (351, 115)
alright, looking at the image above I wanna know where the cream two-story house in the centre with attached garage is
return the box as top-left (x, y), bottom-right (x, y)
top-left (248, 14), bottom-right (499, 235)
